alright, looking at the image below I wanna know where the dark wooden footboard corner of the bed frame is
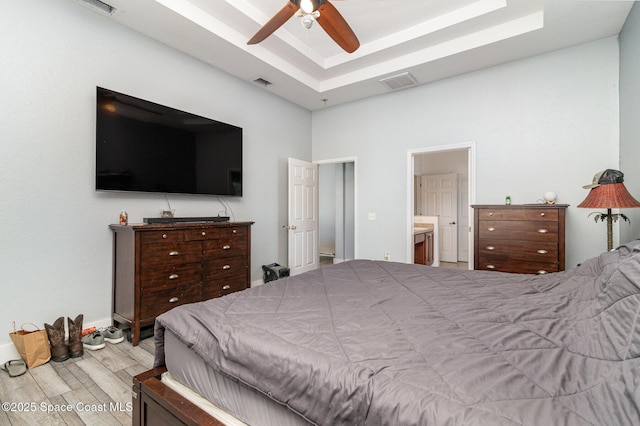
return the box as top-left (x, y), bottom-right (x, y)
top-left (132, 366), bottom-right (225, 426)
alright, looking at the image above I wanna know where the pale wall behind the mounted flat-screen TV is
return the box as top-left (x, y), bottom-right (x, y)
top-left (0, 0), bottom-right (311, 362)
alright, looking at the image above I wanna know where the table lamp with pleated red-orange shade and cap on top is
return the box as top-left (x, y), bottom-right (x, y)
top-left (578, 169), bottom-right (640, 251)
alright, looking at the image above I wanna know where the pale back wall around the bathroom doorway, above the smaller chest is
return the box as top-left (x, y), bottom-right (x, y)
top-left (313, 37), bottom-right (619, 267)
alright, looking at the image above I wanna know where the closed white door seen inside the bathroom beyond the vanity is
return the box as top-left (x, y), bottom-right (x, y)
top-left (422, 173), bottom-right (458, 262)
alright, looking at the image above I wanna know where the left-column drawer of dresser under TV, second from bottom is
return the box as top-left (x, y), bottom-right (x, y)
top-left (140, 262), bottom-right (202, 294)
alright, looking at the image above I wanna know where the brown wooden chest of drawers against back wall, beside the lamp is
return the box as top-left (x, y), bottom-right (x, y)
top-left (472, 204), bottom-right (568, 274)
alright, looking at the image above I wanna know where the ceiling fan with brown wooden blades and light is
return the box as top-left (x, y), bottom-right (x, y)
top-left (247, 0), bottom-right (360, 53)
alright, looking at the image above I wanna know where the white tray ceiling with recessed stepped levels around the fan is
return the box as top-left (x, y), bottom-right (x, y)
top-left (72, 0), bottom-right (634, 110)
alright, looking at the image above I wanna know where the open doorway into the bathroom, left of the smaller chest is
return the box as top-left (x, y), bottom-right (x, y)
top-left (407, 143), bottom-right (475, 269)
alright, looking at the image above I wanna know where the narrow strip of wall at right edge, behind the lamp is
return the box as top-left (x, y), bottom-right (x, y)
top-left (614, 2), bottom-right (640, 242)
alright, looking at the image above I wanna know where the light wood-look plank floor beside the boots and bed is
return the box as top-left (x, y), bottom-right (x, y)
top-left (0, 338), bottom-right (153, 426)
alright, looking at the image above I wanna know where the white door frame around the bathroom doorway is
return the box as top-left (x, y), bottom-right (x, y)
top-left (405, 141), bottom-right (476, 269)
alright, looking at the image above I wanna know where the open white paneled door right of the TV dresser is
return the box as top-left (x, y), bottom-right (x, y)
top-left (287, 158), bottom-right (318, 275)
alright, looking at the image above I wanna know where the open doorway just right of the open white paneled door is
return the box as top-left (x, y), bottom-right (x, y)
top-left (318, 159), bottom-right (356, 266)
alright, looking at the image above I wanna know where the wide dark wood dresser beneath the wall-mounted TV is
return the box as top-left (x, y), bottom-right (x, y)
top-left (109, 222), bottom-right (253, 346)
